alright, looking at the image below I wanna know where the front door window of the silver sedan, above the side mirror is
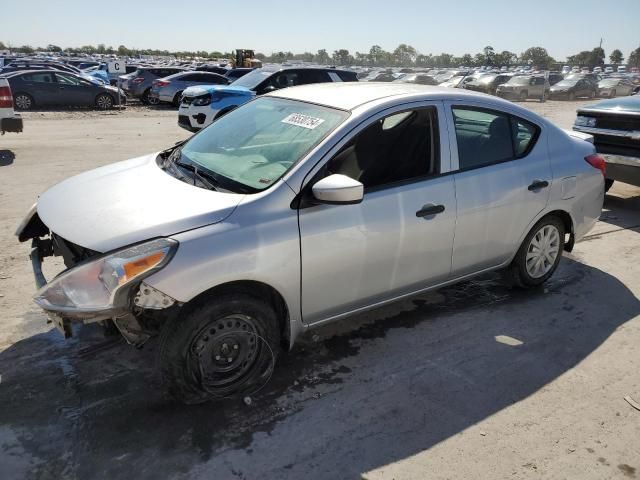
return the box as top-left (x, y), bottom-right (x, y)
top-left (326, 108), bottom-right (440, 189)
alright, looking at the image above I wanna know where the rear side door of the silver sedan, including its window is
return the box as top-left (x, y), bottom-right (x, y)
top-left (447, 102), bottom-right (552, 277)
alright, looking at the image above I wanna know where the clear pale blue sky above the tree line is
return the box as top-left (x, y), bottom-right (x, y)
top-left (5, 0), bottom-right (640, 60)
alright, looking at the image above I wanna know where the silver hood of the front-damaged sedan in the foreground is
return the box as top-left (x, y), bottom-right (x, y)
top-left (37, 154), bottom-right (244, 252)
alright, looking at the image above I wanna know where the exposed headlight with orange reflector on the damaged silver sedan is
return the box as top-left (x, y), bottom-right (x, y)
top-left (34, 238), bottom-right (178, 315)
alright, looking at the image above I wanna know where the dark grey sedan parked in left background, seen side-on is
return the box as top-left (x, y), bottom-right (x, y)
top-left (3, 70), bottom-right (126, 110)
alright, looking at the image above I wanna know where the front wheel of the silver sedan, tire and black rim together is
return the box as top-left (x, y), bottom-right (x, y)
top-left (160, 293), bottom-right (280, 404)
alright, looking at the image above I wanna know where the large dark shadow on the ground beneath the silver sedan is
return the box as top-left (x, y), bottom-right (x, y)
top-left (0, 255), bottom-right (640, 479)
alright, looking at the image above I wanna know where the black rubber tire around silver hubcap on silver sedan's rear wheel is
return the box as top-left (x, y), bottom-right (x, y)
top-left (505, 215), bottom-right (565, 288)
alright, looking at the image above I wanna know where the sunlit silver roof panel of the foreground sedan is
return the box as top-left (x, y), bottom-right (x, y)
top-left (267, 82), bottom-right (502, 110)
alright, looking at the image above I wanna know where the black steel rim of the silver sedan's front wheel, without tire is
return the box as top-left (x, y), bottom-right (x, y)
top-left (189, 314), bottom-right (262, 391)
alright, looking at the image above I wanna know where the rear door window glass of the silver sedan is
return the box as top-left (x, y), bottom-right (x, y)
top-left (453, 107), bottom-right (539, 170)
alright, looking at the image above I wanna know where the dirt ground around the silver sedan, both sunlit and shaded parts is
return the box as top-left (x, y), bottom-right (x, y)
top-left (0, 102), bottom-right (640, 480)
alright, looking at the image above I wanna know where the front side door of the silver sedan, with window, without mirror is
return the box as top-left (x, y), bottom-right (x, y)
top-left (298, 102), bottom-right (456, 324)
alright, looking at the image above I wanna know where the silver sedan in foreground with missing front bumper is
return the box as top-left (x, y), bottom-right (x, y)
top-left (17, 83), bottom-right (604, 403)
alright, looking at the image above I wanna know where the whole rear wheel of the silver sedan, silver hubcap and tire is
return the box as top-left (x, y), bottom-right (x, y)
top-left (509, 216), bottom-right (565, 288)
